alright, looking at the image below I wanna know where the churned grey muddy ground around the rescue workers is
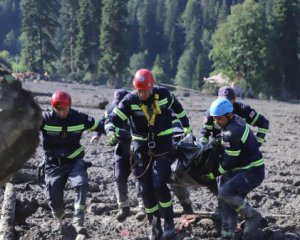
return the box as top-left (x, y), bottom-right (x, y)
top-left (0, 82), bottom-right (300, 240)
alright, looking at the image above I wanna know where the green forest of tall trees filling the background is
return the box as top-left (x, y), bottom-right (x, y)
top-left (0, 0), bottom-right (300, 100)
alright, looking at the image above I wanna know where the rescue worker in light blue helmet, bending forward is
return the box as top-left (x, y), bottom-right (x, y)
top-left (209, 98), bottom-right (264, 240)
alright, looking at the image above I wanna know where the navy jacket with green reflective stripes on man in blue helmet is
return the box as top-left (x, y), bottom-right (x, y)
top-left (217, 115), bottom-right (264, 175)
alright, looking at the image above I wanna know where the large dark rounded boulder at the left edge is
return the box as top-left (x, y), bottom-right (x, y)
top-left (0, 65), bottom-right (41, 184)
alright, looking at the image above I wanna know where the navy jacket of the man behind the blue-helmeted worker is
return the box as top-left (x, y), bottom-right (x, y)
top-left (200, 102), bottom-right (269, 145)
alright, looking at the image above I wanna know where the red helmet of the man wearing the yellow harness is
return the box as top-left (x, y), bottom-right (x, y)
top-left (133, 69), bottom-right (155, 91)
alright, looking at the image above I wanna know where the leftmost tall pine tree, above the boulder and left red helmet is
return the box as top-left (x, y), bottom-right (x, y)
top-left (21, 0), bottom-right (60, 73)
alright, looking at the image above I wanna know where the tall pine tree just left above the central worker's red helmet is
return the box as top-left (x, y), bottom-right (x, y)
top-left (99, 0), bottom-right (127, 86)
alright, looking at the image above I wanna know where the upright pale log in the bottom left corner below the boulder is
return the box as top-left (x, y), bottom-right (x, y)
top-left (0, 183), bottom-right (16, 240)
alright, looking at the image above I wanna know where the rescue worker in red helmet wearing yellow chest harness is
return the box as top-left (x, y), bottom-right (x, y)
top-left (107, 69), bottom-right (192, 239)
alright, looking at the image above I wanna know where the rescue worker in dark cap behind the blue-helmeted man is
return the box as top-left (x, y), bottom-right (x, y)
top-left (199, 86), bottom-right (269, 145)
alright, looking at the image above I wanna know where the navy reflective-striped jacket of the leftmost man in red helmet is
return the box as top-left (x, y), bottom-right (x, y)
top-left (41, 109), bottom-right (104, 159)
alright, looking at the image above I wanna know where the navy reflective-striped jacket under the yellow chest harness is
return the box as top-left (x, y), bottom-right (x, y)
top-left (111, 86), bottom-right (191, 154)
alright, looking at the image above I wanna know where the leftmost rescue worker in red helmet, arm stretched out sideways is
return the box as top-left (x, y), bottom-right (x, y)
top-left (41, 91), bottom-right (104, 233)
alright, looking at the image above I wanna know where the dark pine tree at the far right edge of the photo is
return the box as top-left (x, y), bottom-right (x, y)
top-left (270, 0), bottom-right (300, 100)
